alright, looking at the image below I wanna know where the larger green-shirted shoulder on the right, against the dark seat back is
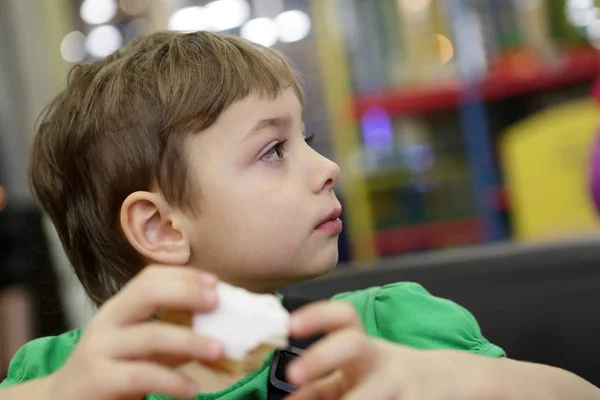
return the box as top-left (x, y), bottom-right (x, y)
top-left (333, 282), bottom-right (505, 357)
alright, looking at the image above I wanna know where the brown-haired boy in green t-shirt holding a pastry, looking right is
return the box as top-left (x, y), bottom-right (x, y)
top-left (0, 32), bottom-right (600, 400)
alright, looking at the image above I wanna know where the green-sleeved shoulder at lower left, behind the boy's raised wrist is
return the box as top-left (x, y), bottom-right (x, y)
top-left (0, 329), bottom-right (83, 387)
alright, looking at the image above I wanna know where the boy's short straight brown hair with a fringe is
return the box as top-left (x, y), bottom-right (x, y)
top-left (30, 32), bottom-right (303, 305)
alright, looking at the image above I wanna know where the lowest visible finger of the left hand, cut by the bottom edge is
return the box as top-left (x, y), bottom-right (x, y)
top-left (103, 362), bottom-right (200, 398)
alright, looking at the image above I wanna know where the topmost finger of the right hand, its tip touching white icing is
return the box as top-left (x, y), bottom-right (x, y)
top-left (290, 301), bottom-right (362, 338)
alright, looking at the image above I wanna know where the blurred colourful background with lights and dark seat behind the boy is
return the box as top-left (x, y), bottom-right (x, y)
top-left (0, 0), bottom-right (600, 380)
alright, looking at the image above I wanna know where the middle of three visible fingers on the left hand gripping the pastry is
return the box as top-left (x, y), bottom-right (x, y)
top-left (112, 322), bottom-right (223, 364)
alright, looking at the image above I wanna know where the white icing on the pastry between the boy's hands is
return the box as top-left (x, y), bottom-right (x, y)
top-left (193, 282), bottom-right (290, 360)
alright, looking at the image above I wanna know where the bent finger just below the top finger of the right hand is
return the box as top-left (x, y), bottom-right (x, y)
top-left (287, 328), bottom-right (371, 386)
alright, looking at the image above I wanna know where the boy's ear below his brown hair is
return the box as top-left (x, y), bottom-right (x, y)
top-left (121, 192), bottom-right (191, 265)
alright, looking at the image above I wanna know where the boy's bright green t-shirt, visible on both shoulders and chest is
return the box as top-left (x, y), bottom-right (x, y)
top-left (0, 283), bottom-right (505, 400)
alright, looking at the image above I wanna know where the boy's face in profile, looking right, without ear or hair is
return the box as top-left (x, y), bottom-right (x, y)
top-left (184, 89), bottom-right (341, 292)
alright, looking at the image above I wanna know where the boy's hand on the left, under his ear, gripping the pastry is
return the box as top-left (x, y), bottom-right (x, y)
top-left (44, 266), bottom-right (223, 400)
